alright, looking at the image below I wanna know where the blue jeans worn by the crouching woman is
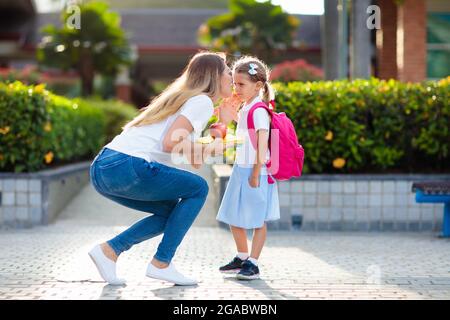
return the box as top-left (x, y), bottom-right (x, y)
top-left (90, 148), bottom-right (208, 263)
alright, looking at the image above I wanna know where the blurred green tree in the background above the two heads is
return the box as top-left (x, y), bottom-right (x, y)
top-left (199, 0), bottom-right (300, 60)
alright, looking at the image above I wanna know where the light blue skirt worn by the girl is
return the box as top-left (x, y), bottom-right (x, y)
top-left (216, 165), bottom-right (280, 229)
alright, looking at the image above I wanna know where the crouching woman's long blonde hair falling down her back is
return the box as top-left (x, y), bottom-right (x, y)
top-left (122, 52), bottom-right (226, 130)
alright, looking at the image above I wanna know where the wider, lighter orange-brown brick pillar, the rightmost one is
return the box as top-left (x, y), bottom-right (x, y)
top-left (397, 0), bottom-right (427, 82)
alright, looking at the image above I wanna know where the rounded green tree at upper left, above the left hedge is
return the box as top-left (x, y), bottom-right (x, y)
top-left (37, 2), bottom-right (132, 96)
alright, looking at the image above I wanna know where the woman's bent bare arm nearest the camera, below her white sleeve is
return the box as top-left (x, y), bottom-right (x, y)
top-left (162, 115), bottom-right (225, 168)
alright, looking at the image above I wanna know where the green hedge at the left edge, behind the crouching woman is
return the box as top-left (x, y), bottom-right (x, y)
top-left (0, 82), bottom-right (106, 172)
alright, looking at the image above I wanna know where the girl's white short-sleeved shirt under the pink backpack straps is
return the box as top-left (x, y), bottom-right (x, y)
top-left (235, 97), bottom-right (270, 173)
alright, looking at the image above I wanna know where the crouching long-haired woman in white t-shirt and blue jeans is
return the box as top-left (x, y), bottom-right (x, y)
top-left (89, 52), bottom-right (232, 285)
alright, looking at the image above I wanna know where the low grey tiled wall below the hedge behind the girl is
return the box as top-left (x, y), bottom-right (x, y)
top-left (213, 165), bottom-right (450, 231)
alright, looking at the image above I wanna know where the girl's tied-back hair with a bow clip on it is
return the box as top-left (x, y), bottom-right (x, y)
top-left (233, 56), bottom-right (275, 105)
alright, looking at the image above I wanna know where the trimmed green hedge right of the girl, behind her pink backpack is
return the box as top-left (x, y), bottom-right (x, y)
top-left (274, 77), bottom-right (450, 173)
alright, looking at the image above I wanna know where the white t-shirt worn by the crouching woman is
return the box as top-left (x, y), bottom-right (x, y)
top-left (105, 94), bottom-right (214, 169)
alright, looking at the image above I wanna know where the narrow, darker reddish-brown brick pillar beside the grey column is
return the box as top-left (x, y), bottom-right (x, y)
top-left (376, 0), bottom-right (398, 80)
